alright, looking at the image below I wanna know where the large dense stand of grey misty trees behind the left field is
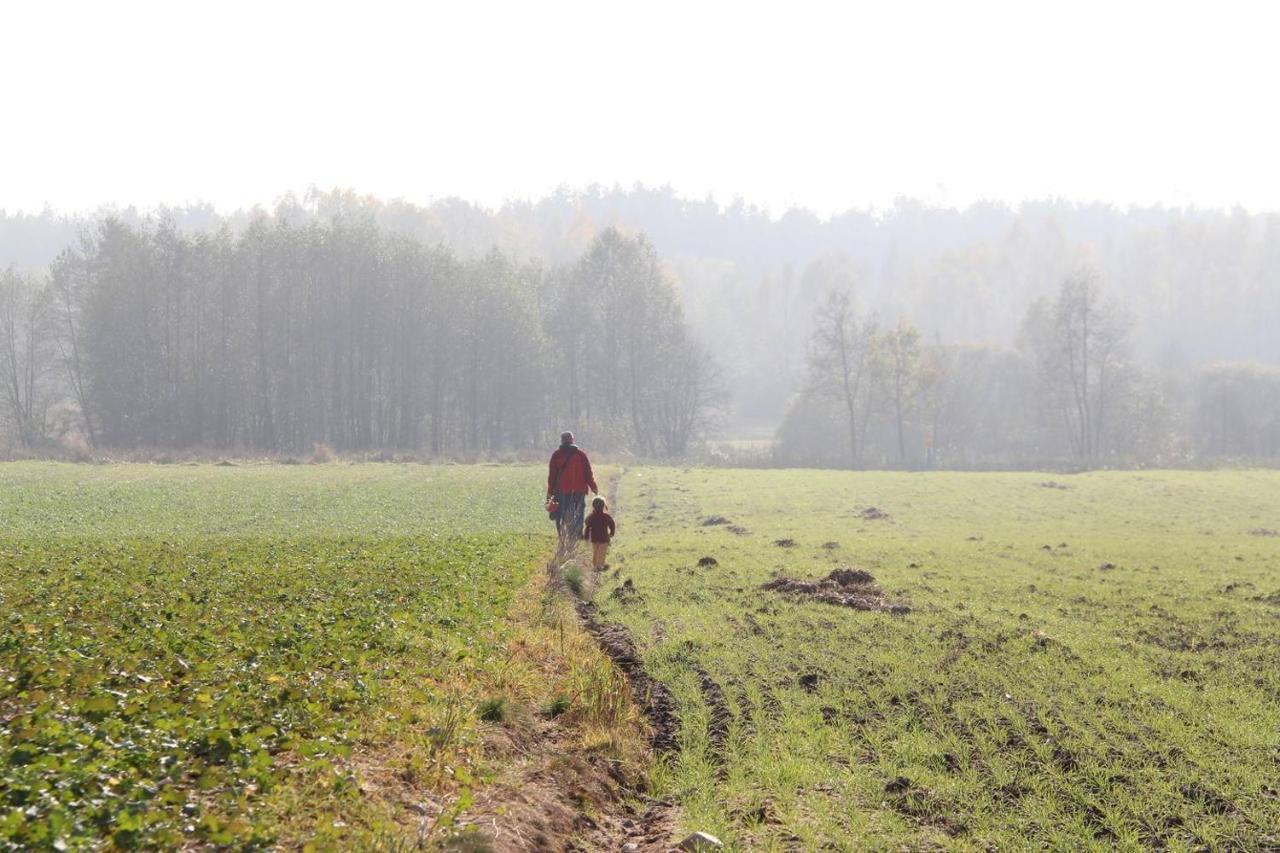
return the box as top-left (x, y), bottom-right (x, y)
top-left (0, 215), bottom-right (719, 456)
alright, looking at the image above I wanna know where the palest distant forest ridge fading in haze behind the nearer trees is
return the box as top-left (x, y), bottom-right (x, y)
top-left (10, 186), bottom-right (1280, 429)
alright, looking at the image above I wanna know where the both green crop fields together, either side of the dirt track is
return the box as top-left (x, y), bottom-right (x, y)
top-left (0, 462), bottom-right (1280, 849)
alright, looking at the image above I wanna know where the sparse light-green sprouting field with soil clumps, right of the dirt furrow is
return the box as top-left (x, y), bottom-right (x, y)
top-left (596, 469), bottom-right (1280, 849)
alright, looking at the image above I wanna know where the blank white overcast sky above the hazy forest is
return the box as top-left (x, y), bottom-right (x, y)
top-left (0, 0), bottom-right (1280, 214)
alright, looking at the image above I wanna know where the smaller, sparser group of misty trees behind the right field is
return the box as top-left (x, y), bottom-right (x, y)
top-left (769, 273), bottom-right (1280, 467)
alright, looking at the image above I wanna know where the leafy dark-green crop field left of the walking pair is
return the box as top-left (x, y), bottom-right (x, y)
top-left (0, 464), bottom-right (548, 848)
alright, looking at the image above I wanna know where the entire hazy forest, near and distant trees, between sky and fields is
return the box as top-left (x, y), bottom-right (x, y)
top-left (0, 188), bottom-right (1280, 466)
